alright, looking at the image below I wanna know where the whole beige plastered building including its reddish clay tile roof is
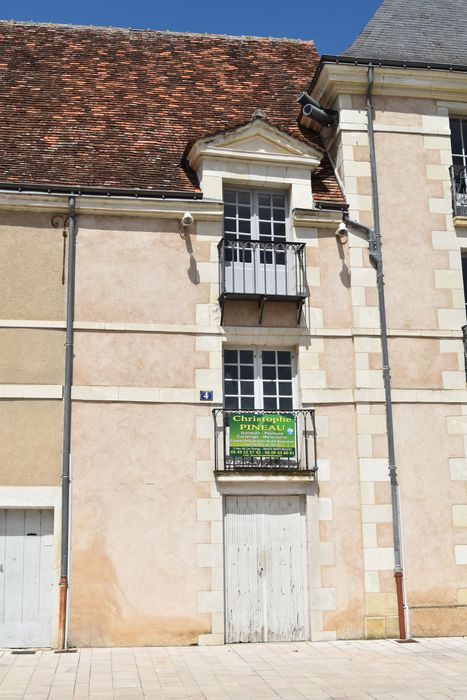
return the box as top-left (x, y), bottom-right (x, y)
top-left (0, 1), bottom-right (467, 647)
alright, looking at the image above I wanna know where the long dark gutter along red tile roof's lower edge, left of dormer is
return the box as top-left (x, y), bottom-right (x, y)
top-left (0, 182), bottom-right (203, 200)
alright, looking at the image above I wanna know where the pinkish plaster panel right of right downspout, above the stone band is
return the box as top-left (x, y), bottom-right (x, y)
top-left (376, 133), bottom-right (452, 328)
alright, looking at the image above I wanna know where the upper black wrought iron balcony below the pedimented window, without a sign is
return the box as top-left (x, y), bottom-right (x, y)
top-left (218, 238), bottom-right (308, 323)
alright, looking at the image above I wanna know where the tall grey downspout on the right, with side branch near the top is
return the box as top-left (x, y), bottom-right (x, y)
top-left (347, 64), bottom-right (408, 640)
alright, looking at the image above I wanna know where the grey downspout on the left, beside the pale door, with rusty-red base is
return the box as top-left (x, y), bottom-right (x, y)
top-left (58, 197), bottom-right (76, 649)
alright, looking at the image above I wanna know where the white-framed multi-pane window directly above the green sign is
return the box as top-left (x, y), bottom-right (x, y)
top-left (224, 349), bottom-right (294, 411)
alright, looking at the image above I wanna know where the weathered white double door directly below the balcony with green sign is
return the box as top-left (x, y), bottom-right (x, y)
top-left (224, 496), bottom-right (309, 643)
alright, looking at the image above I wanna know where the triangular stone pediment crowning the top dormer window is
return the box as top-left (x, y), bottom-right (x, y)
top-left (188, 118), bottom-right (323, 172)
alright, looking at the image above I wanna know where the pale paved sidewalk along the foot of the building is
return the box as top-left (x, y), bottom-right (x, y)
top-left (0, 638), bottom-right (467, 700)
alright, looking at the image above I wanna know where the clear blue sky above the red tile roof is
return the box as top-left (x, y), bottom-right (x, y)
top-left (0, 0), bottom-right (382, 54)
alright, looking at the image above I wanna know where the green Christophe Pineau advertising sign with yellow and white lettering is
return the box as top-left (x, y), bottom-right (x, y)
top-left (229, 413), bottom-right (296, 457)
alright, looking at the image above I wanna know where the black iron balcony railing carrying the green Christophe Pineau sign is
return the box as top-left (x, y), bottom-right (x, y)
top-left (212, 408), bottom-right (317, 474)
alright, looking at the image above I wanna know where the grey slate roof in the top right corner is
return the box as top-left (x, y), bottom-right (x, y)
top-left (343, 0), bottom-right (467, 66)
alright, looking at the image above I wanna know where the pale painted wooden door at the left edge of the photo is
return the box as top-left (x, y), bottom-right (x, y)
top-left (0, 509), bottom-right (54, 647)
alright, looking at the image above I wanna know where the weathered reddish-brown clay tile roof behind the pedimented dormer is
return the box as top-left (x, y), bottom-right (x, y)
top-left (0, 22), bottom-right (342, 201)
